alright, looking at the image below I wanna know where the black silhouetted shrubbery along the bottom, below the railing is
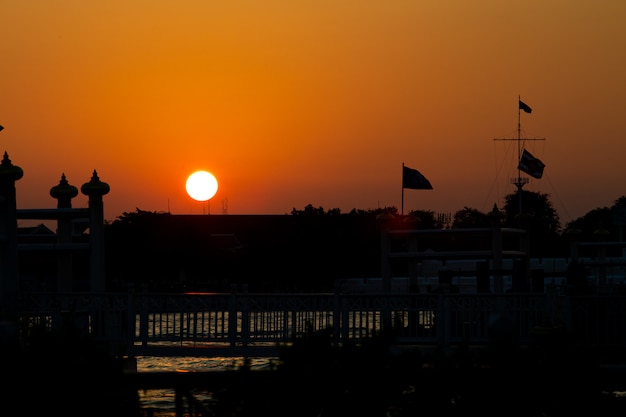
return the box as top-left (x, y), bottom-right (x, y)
top-left (0, 322), bottom-right (626, 417)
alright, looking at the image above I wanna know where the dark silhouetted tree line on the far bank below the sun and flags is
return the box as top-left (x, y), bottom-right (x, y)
top-left (94, 191), bottom-right (626, 291)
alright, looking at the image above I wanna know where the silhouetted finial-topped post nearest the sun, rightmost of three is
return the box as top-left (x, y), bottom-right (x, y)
top-left (80, 169), bottom-right (110, 293)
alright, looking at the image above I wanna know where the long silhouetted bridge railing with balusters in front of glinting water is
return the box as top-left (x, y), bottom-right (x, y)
top-left (20, 292), bottom-right (626, 350)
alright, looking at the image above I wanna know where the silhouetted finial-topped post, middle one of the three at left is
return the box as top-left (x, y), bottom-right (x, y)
top-left (50, 174), bottom-right (78, 292)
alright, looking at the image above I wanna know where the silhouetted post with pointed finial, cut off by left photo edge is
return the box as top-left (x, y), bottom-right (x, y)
top-left (0, 151), bottom-right (24, 316)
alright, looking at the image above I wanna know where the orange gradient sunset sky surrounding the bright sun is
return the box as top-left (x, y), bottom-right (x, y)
top-left (0, 0), bottom-right (626, 224)
